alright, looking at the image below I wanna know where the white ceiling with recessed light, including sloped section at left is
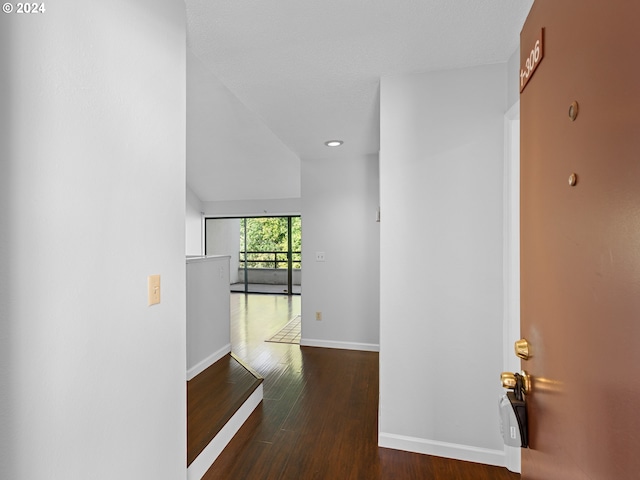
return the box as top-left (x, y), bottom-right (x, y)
top-left (185, 0), bottom-right (533, 201)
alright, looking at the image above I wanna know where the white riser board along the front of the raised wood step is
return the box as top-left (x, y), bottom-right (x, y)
top-left (187, 384), bottom-right (264, 480)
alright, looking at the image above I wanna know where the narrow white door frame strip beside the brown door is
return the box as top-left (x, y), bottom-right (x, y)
top-left (502, 100), bottom-right (521, 473)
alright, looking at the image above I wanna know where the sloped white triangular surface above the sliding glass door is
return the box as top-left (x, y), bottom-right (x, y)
top-left (187, 49), bottom-right (300, 201)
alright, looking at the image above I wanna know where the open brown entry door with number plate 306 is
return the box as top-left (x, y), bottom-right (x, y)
top-left (520, 0), bottom-right (640, 480)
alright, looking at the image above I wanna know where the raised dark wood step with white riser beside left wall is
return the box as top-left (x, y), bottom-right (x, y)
top-left (187, 353), bottom-right (263, 480)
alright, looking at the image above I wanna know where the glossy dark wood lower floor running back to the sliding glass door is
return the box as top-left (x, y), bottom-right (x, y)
top-left (203, 295), bottom-right (520, 480)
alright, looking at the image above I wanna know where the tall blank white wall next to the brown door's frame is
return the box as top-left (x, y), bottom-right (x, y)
top-left (379, 64), bottom-right (507, 465)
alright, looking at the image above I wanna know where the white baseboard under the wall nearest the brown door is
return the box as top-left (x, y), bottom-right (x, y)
top-left (378, 432), bottom-right (505, 467)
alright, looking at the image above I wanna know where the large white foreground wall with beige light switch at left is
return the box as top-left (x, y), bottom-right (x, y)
top-left (0, 0), bottom-right (186, 480)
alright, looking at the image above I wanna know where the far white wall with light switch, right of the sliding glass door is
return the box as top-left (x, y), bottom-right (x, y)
top-left (301, 155), bottom-right (380, 351)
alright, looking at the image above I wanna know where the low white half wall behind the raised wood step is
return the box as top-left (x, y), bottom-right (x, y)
top-left (187, 256), bottom-right (231, 380)
